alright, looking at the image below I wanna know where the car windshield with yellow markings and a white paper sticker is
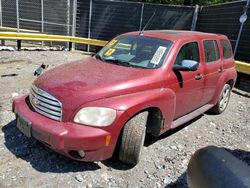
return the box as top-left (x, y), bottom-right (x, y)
top-left (95, 35), bottom-right (172, 69)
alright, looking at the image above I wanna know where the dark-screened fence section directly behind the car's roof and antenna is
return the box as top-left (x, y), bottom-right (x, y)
top-left (76, 0), bottom-right (195, 51)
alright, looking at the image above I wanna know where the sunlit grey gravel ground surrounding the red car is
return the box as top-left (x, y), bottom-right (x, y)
top-left (0, 51), bottom-right (250, 188)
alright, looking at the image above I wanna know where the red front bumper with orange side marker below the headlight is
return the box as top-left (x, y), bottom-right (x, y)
top-left (13, 96), bottom-right (126, 161)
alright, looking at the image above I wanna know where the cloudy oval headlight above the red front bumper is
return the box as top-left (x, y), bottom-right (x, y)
top-left (74, 107), bottom-right (116, 127)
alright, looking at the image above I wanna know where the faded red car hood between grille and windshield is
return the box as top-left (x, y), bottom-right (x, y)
top-left (34, 57), bottom-right (161, 119)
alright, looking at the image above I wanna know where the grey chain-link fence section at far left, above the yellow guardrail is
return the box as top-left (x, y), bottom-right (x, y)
top-left (0, 0), bottom-right (76, 35)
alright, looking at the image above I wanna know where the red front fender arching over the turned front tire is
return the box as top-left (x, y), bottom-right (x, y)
top-left (78, 88), bottom-right (176, 132)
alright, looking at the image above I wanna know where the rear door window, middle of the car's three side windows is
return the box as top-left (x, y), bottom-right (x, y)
top-left (203, 40), bottom-right (220, 63)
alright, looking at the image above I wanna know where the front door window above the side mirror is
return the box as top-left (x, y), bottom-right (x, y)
top-left (174, 42), bottom-right (200, 65)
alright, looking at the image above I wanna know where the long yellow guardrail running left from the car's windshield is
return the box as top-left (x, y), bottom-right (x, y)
top-left (0, 32), bottom-right (108, 46)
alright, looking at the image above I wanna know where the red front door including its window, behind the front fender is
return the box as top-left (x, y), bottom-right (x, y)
top-left (169, 42), bottom-right (204, 119)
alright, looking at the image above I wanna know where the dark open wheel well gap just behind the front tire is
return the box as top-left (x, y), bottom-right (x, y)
top-left (143, 107), bottom-right (164, 136)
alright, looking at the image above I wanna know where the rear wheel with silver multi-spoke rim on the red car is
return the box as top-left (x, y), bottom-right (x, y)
top-left (211, 84), bottom-right (231, 114)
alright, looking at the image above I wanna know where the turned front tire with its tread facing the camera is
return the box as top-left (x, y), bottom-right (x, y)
top-left (119, 112), bottom-right (148, 165)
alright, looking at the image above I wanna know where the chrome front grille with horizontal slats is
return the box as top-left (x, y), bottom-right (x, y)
top-left (29, 85), bottom-right (62, 121)
